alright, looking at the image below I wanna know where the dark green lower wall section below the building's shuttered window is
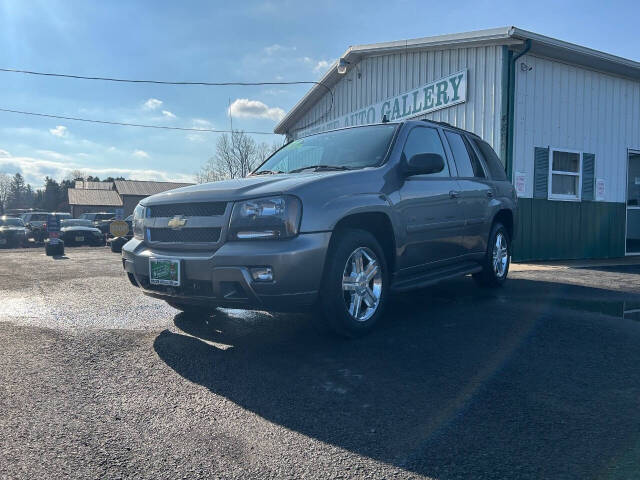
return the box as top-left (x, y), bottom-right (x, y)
top-left (512, 198), bottom-right (626, 261)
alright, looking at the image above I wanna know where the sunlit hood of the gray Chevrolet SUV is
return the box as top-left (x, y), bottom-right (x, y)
top-left (141, 171), bottom-right (344, 206)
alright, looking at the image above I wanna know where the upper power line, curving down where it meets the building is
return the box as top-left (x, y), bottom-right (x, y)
top-left (0, 68), bottom-right (334, 130)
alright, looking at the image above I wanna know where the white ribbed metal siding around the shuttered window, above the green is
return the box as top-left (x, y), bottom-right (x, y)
top-left (514, 55), bottom-right (640, 202)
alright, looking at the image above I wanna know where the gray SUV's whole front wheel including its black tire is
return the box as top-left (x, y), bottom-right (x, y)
top-left (320, 229), bottom-right (389, 338)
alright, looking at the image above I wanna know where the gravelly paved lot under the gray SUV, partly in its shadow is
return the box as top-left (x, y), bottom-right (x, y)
top-left (0, 248), bottom-right (640, 479)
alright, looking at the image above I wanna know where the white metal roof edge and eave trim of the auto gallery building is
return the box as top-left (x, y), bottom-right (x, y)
top-left (273, 26), bottom-right (640, 134)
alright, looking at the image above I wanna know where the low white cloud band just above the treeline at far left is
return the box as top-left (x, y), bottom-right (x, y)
top-left (0, 157), bottom-right (194, 187)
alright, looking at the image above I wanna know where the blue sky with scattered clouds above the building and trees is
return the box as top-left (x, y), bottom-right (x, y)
top-left (0, 0), bottom-right (640, 187)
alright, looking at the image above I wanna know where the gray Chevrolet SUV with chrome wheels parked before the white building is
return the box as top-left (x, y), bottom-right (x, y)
top-left (122, 121), bottom-right (516, 336)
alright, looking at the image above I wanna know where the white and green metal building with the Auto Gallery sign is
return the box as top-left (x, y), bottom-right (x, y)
top-left (275, 27), bottom-right (640, 260)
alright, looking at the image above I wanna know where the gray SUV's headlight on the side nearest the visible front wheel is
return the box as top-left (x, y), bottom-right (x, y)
top-left (229, 195), bottom-right (302, 240)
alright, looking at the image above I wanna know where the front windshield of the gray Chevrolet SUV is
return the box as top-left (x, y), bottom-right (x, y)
top-left (253, 125), bottom-right (396, 175)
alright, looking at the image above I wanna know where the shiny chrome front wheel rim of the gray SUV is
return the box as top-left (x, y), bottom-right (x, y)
top-left (342, 247), bottom-right (382, 322)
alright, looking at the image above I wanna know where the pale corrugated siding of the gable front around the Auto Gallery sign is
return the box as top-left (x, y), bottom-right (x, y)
top-left (291, 45), bottom-right (503, 151)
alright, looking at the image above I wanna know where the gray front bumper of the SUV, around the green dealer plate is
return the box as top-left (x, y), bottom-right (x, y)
top-left (122, 232), bottom-right (331, 311)
